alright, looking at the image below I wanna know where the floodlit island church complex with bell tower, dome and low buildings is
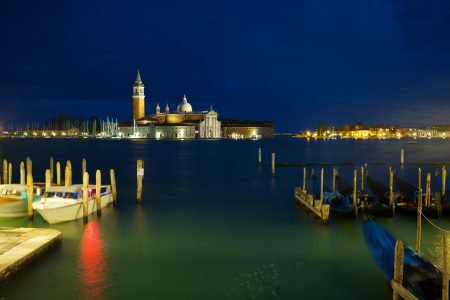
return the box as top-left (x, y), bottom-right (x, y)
top-left (118, 70), bottom-right (274, 139)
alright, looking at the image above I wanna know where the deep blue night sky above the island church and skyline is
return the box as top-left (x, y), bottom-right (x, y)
top-left (0, 0), bottom-right (450, 131)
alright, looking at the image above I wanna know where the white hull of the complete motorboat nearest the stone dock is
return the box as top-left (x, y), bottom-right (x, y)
top-left (35, 194), bottom-right (113, 224)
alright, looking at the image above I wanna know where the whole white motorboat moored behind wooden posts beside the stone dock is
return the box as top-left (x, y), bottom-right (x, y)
top-left (33, 184), bottom-right (113, 224)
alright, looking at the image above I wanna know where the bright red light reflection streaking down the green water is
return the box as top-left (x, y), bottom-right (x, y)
top-left (79, 221), bottom-right (107, 299)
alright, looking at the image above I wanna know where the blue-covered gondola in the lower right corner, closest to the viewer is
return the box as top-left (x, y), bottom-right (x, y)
top-left (363, 221), bottom-right (442, 299)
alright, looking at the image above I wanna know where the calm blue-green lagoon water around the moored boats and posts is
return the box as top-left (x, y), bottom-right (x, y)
top-left (0, 138), bottom-right (450, 299)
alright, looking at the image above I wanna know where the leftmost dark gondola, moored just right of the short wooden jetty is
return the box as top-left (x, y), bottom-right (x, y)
top-left (336, 175), bottom-right (393, 217)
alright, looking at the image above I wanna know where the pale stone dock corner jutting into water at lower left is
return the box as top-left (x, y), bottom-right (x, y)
top-left (0, 227), bottom-right (61, 281)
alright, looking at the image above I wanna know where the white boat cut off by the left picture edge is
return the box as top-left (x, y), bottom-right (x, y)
top-left (0, 184), bottom-right (43, 217)
